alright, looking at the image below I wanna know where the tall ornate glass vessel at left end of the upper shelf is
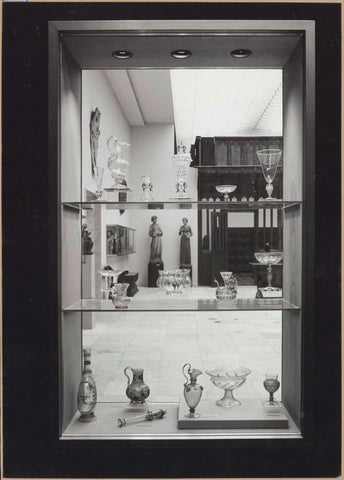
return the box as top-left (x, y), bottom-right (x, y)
top-left (106, 135), bottom-right (130, 189)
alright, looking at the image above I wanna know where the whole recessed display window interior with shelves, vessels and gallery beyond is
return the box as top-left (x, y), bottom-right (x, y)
top-left (58, 24), bottom-right (305, 439)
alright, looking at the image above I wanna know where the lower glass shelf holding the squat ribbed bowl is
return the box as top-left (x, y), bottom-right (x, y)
top-left (63, 294), bottom-right (300, 312)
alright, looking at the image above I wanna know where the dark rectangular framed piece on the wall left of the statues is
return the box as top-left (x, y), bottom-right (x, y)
top-left (106, 225), bottom-right (135, 256)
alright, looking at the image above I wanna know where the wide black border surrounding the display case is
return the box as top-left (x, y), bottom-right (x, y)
top-left (2, 2), bottom-right (341, 478)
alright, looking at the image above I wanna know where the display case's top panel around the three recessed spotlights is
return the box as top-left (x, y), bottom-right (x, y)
top-left (64, 33), bottom-right (301, 69)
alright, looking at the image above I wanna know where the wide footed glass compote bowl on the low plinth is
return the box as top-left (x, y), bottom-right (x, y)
top-left (206, 366), bottom-right (251, 407)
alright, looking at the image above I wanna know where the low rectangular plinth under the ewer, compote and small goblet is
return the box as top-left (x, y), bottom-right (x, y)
top-left (178, 398), bottom-right (289, 429)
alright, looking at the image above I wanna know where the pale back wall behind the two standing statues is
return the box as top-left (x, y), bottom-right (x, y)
top-left (129, 124), bottom-right (198, 285)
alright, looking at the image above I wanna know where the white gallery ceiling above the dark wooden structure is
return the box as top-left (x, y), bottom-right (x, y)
top-left (106, 69), bottom-right (282, 146)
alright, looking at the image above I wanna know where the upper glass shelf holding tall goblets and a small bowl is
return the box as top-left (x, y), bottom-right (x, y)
top-left (62, 200), bottom-right (302, 211)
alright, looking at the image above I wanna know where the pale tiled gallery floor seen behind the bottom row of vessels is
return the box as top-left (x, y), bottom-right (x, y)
top-left (83, 286), bottom-right (282, 402)
